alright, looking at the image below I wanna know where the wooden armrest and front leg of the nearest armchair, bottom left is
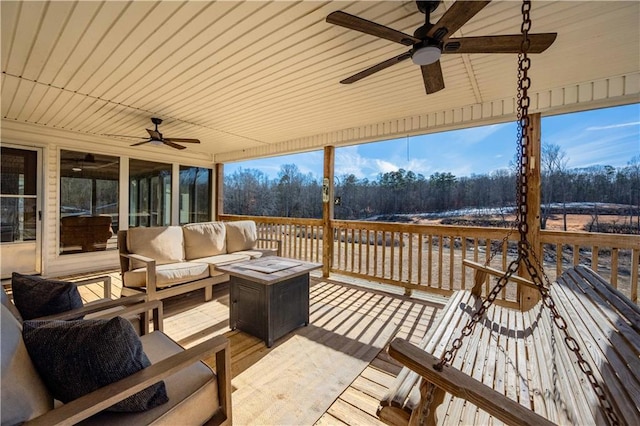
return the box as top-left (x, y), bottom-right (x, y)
top-left (23, 336), bottom-right (231, 426)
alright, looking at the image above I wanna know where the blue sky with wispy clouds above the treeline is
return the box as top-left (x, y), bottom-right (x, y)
top-left (225, 104), bottom-right (640, 180)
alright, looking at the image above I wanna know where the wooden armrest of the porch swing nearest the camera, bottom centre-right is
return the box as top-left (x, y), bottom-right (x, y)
top-left (389, 338), bottom-right (554, 426)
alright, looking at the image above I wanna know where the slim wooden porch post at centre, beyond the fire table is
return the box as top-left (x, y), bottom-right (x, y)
top-left (322, 146), bottom-right (335, 277)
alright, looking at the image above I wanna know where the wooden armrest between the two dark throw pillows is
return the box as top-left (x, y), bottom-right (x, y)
top-left (38, 295), bottom-right (164, 336)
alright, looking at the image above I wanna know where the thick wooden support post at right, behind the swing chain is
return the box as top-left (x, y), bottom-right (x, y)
top-left (518, 113), bottom-right (543, 311)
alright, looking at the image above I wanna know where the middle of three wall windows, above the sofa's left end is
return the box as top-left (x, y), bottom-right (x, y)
top-left (129, 159), bottom-right (171, 227)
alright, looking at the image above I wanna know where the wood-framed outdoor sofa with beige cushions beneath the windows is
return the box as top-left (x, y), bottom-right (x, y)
top-left (118, 220), bottom-right (280, 301)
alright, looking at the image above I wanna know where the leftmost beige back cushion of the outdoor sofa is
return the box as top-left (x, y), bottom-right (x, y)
top-left (127, 226), bottom-right (184, 269)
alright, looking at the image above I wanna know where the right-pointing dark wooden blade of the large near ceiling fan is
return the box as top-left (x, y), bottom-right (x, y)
top-left (442, 33), bottom-right (558, 53)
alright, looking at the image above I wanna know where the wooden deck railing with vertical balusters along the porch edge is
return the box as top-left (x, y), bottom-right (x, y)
top-left (220, 215), bottom-right (640, 304)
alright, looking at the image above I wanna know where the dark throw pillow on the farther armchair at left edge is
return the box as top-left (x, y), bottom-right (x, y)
top-left (11, 272), bottom-right (83, 320)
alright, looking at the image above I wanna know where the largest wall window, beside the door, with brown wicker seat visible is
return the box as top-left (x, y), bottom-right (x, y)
top-left (60, 150), bottom-right (120, 254)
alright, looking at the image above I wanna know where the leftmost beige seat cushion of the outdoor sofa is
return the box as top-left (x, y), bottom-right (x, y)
top-left (122, 262), bottom-right (209, 288)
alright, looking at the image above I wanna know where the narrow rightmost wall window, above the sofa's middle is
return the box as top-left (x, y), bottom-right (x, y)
top-left (180, 166), bottom-right (211, 225)
